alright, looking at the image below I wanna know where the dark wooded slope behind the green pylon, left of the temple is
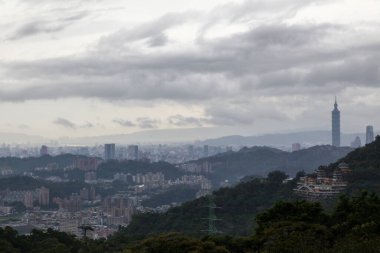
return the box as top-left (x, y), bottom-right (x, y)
top-left (124, 171), bottom-right (295, 236)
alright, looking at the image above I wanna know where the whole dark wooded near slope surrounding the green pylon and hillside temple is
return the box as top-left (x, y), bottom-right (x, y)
top-left (0, 138), bottom-right (380, 253)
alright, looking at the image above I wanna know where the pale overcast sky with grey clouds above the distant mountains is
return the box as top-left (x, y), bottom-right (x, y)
top-left (0, 0), bottom-right (380, 138)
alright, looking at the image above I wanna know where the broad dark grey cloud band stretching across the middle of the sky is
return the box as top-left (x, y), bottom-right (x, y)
top-left (0, 21), bottom-right (379, 101)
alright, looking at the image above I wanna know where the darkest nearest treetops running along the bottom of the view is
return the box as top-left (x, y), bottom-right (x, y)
top-left (0, 192), bottom-right (380, 253)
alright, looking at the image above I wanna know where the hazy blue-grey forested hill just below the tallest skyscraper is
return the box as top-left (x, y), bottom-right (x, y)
top-left (195, 145), bottom-right (352, 181)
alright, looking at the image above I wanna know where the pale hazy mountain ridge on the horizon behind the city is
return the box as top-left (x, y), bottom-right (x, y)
top-left (0, 127), bottom-right (374, 147)
